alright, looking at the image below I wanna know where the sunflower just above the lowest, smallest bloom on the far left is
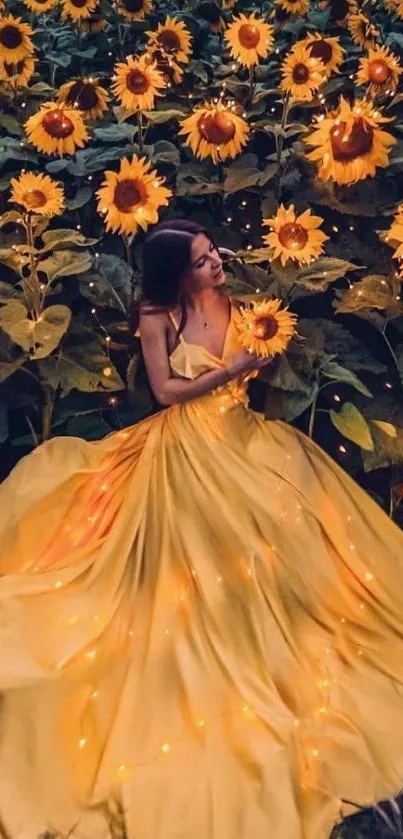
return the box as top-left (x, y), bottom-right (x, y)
top-left (25, 102), bottom-right (88, 155)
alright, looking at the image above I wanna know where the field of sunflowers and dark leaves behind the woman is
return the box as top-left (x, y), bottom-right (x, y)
top-left (0, 0), bottom-right (403, 523)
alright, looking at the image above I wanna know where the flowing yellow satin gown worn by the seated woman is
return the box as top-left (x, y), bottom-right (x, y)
top-left (0, 305), bottom-right (403, 839)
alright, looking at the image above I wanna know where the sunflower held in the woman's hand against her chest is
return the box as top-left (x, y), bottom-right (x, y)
top-left (237, 299), bottom-right (297, 358)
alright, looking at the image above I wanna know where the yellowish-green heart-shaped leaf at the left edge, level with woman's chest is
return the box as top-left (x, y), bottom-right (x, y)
top-left (0, 301), bottom-right (71, 358)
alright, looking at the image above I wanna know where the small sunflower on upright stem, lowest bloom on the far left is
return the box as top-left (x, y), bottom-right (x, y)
top-left (10, 172), bottom-right (64, 218)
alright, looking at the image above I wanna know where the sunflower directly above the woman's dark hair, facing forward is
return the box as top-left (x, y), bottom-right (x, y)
top-left (97, 156), bottom-right (172, 236)
